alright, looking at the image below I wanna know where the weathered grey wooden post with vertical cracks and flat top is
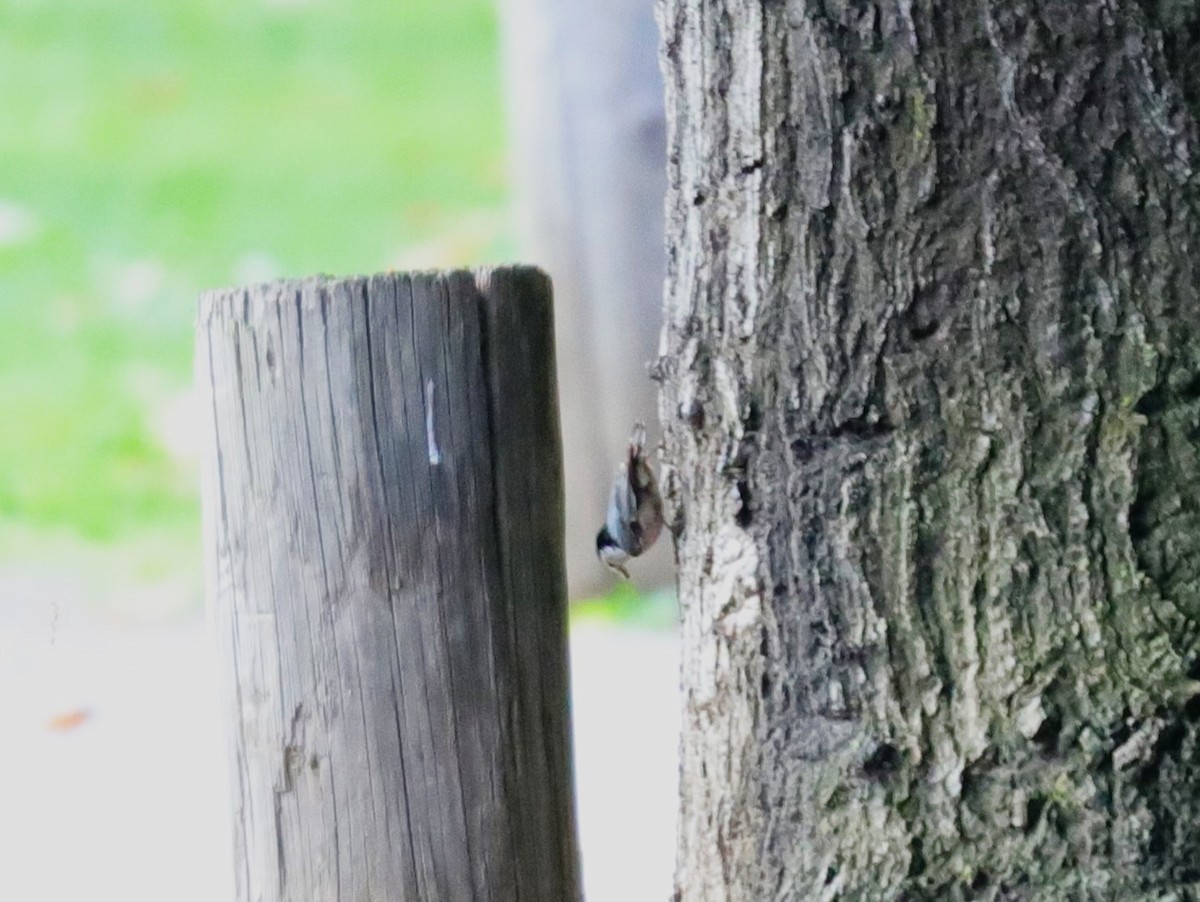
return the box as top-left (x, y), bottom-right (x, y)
top-left (197, 267), bottom-right (580, 902)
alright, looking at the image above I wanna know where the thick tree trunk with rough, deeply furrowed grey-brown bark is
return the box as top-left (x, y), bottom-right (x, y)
top-left (659, 0), bottom-right (1200, 900)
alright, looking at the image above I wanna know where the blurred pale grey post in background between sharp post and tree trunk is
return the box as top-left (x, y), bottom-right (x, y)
top-left (500, 0), bottom-right (673, 597)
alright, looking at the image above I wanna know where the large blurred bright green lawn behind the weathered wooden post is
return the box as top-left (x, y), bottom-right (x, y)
top-left (0, 0), bottom-right (509, 553)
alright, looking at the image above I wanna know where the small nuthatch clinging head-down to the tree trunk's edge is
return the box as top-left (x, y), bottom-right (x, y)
top-left (596, 423), bottom-right (662, 579)
